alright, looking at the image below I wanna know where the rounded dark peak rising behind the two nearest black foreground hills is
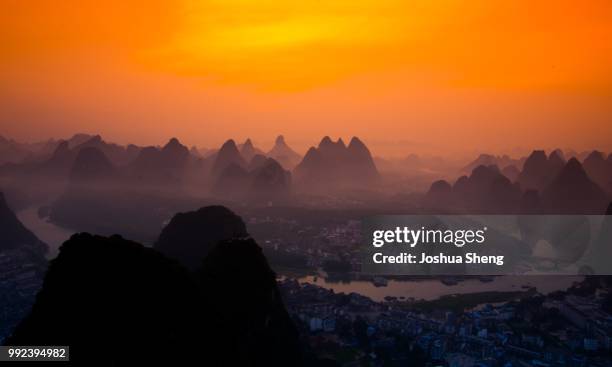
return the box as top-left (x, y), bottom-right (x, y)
top-left (154, 206), bottom-right (248, 269)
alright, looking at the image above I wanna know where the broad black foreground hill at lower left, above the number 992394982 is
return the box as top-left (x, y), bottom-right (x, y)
top-left (7, 233), bottom-right (201, 365)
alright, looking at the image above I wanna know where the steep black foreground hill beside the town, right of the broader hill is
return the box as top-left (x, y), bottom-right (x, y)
top-left (197, 239), bottom-right (300, 366)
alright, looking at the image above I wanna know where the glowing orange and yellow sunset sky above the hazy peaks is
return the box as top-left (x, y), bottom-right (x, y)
top-left (0, 0), bottom-right (612, 155)
